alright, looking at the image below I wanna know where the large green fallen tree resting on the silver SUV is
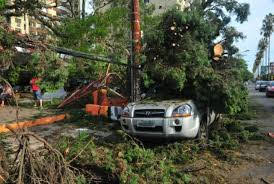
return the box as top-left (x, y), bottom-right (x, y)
top-left (143, 0), bottom-right (252, 114)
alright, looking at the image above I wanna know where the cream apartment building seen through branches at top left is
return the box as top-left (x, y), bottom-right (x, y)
top-left (8, 0), bottom-right (57, 35)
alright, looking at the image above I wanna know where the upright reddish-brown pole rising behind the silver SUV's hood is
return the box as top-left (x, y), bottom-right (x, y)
top-left (131, 0), bottom-right (142, 101)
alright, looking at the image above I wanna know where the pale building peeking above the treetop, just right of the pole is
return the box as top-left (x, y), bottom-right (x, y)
top-left (144, 0), bottom-right (188, 15)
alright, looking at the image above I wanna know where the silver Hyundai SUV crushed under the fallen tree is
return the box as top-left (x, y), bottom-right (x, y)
top-left (120, 100), bottom-right (215, 139)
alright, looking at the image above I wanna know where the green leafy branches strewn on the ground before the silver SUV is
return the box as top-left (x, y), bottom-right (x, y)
top-left (53, 119), bottom-right (261, 183)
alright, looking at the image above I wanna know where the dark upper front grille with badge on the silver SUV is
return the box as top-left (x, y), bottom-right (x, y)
top-left (134, 109), bottom-right (165, 118)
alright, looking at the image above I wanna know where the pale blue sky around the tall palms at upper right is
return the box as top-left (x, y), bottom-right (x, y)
top-left (232, 0), bottom-right (274, 71)
